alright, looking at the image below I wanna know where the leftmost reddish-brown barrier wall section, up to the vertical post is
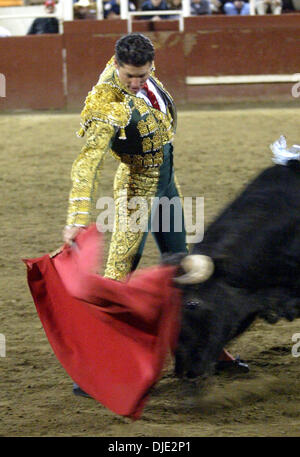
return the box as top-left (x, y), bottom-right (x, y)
top-left (0, 35), bottom-right (67, 110)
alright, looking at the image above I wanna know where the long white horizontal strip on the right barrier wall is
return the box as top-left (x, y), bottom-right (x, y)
top-left (185, 73), bottom-right (300, 86)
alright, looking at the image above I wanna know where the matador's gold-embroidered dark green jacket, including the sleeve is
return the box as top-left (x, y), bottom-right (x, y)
top-left (67, 57), bottom-right (176, 226)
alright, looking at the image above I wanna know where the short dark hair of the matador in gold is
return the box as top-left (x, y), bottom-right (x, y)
top-left (115, 33), bottom-right (155, 67)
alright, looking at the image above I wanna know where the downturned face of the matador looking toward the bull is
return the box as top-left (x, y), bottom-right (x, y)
top-left (116, 62), bottom-right (153, 94)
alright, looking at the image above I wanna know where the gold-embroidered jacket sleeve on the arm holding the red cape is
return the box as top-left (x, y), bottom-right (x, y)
top-left (67, 121), bottom-right (116, 227)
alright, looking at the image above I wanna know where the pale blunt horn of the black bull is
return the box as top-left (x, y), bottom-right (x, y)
top-left (174, 255), bottom-right (214, 284)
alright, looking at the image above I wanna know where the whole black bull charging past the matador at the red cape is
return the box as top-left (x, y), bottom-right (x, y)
top-left (168, 160), bottom-right (300, 378)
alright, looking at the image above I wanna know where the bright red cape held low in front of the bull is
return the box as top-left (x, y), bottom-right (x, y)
top-left (24, 225), bottom-right (181, 419)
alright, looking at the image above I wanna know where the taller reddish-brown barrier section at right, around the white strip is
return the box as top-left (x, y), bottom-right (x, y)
top-left (185, 14), bottom-right (300, 102)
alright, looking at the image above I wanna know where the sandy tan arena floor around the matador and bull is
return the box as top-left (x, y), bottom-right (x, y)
top-left (0, 102), bottom-right (300, 437)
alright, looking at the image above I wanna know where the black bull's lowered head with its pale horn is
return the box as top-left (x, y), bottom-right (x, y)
top-left (174, 255), bottom-right (258, 378)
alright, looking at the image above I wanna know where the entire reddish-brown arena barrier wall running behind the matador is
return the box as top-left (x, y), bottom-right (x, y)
top-left (0, 14), bottom-right (300, 110)
